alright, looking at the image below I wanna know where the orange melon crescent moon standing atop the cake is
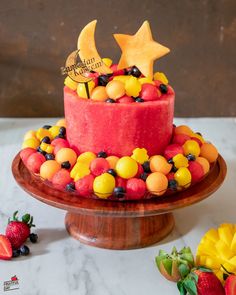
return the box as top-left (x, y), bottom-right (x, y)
top-left (77, 20), bottom-right (112, 74)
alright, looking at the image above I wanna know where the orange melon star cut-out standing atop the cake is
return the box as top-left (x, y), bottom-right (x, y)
top-left (113, 21), bottom-right (170, 78)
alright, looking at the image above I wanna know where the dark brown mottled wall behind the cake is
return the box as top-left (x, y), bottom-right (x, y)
top-left (0, 0), bottom-right (236, 117)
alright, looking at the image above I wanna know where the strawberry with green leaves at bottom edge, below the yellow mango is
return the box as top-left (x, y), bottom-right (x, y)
top-left (177, 267), bottom-right (225, 295)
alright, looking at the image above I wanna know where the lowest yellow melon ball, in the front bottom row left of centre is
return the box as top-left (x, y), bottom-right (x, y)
top-left (93, 173), bottom-right (116, 199)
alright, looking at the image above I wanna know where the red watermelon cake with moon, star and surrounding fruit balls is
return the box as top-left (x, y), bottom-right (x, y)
top-left (20, 21), bottom-right (218, 201)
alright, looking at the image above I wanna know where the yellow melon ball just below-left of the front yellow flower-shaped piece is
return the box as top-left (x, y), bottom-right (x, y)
top-left (116, 156), bottom-right (138, 179)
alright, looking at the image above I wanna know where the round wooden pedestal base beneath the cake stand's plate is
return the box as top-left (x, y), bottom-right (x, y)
top-left (65, 212), bottom-right (174, 250)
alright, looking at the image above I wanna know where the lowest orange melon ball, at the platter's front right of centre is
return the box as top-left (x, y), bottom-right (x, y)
top-left (146, 172), bottom-right (168, 196)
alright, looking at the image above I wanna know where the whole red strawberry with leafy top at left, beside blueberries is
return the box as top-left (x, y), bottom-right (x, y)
top-left (6, 211), bottom-right (35, 249)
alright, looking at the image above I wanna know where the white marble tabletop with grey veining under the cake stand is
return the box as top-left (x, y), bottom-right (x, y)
top-left (0, 118), bottom-right (236, 295)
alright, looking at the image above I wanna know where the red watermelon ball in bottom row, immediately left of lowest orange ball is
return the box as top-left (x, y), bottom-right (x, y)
top-left (126, 178), bottom-right (146, 200)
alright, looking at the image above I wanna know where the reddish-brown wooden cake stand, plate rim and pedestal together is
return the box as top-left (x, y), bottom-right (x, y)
top-left (12, 154), bottom-right (227, 250)
